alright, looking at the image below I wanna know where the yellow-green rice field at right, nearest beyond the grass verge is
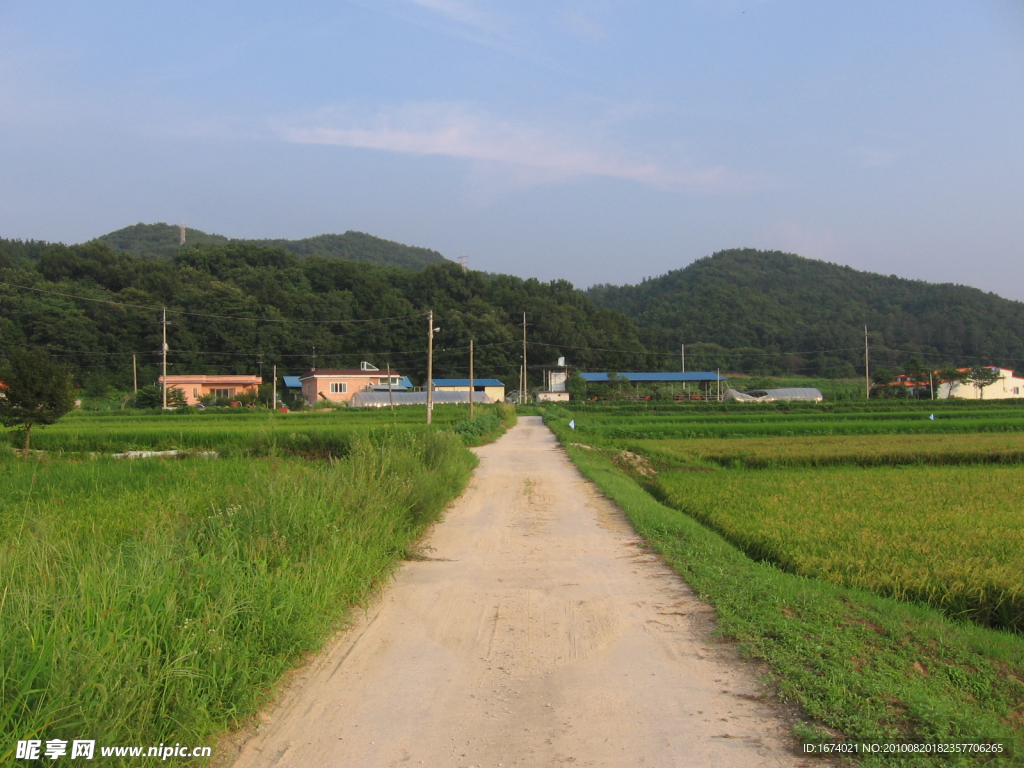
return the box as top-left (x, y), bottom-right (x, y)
top-left (654, 466), bottom-right (1024, 630)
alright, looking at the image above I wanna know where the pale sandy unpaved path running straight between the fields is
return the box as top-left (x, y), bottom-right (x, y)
top-left (236, 417), bottom-right (804, 768)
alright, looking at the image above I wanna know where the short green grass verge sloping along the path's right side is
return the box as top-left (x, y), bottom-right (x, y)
top-left (563, 442), bottom-right (1024, 766)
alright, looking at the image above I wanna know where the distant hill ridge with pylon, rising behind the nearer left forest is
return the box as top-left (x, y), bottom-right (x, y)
top-left (96, 224), bottom-right (447, 269)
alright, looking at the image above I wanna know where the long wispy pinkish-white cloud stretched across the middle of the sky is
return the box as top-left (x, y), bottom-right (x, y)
top-left (275, 103), bottom-right (738, 187)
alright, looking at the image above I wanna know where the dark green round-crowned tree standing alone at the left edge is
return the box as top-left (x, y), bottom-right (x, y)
top-left (0, 348), bottom-right (75, 458)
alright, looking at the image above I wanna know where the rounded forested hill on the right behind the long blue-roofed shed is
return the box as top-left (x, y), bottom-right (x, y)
top-left (586, 249), bottom-right (1024, 376)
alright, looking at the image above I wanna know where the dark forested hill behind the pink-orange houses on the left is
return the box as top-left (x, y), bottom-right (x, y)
top-left (0, 240), bottom-right (655, 389)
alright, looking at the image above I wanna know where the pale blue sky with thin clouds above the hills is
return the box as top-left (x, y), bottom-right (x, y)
top-left (0, 0), bottom-right (1024, 300)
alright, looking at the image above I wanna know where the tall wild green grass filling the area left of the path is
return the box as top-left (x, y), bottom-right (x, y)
top-left (0, 432), bottom-right (474, 763)
